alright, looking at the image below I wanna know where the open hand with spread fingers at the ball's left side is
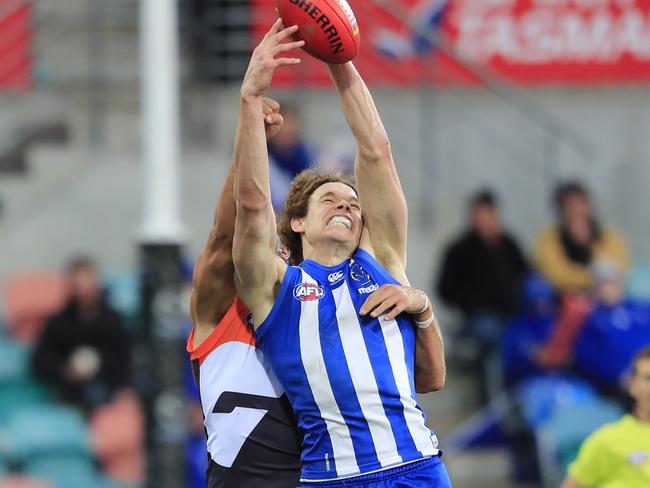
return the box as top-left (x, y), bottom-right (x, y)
top-left (241, 19), bottom-right (305, 96)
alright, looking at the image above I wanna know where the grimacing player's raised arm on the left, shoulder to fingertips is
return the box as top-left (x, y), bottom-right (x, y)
top-left (233, 19), bottom-right (304, 325)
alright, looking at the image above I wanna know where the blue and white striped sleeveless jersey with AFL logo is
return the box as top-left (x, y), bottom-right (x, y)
top-left (256, 249), bottom-right (438, 481)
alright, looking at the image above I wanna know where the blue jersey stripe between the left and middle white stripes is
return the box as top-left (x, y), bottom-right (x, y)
top-left (318, 290), bottom-right (382, 475)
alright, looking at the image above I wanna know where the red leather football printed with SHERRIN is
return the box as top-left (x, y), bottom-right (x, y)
top-left (275, 0), bottom-right (360, 64)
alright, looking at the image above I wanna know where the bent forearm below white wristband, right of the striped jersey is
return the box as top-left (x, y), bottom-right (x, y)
top-left (415, 306), bottom-right (447, 393)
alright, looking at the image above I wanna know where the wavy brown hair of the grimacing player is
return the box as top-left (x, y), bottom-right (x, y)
top-left (278, 169), bottom-right (357, 266)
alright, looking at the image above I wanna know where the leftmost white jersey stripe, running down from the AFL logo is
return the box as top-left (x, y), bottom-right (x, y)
top-left (298, 270), bottom-right (359, 474)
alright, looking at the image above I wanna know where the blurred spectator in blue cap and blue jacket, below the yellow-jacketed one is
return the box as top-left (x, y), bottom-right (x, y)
top-left (503, 274), bottom-right (557, 385)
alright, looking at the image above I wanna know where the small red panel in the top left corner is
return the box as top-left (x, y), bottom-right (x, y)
top-left (0, 0), bottom-right (31, 90)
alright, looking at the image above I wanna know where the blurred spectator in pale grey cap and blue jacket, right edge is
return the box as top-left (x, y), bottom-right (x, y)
top-left (575, 262), bottom-right (650, 393)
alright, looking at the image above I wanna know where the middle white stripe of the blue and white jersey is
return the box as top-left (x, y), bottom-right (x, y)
top-left (332, 281), bottom-right (403, 467)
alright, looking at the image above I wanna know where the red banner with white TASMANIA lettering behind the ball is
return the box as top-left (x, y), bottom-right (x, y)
top-left (254, 0), bottom-right (650, 86)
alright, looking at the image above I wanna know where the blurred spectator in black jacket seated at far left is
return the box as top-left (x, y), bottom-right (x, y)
top-left (32, 258), bottom-right (131, 411)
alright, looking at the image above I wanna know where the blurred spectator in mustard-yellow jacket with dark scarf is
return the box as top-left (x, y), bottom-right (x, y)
top-left (537, 181), bottom-right (629, 293)
